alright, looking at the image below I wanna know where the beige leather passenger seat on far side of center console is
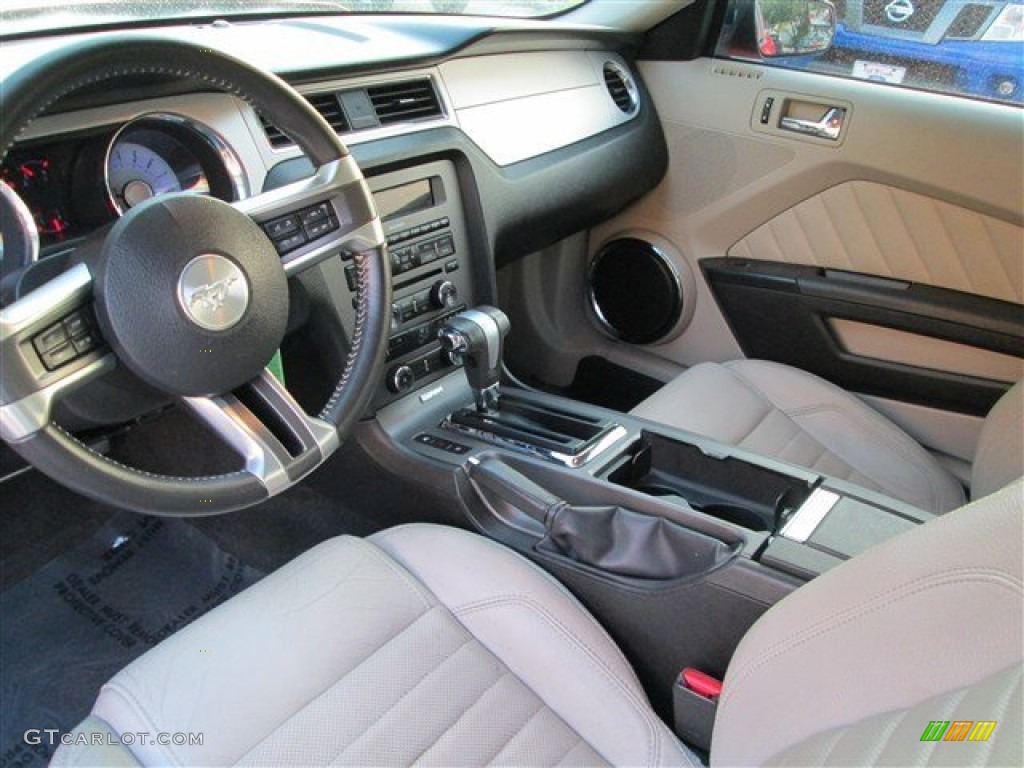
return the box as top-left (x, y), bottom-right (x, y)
top-left (632, 359), bottom-right (1024, 514)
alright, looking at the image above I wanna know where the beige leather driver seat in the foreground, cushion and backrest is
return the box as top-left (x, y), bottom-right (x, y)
top-left (53, 481), bottom-right (1024, 766)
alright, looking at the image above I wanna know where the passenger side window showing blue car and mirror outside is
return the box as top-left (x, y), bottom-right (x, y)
top-left (716, 0), bottom-right (1024, 104)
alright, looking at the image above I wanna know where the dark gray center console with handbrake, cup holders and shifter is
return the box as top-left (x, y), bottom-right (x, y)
top-left (365, 303), bottom-right (931, 719)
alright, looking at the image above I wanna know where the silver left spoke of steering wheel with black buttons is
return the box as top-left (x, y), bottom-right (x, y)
top-left (0, 264), bottom-right (116, 443)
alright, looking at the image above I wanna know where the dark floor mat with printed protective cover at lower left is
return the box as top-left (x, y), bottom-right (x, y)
top-left (0, 512), bottom-right (262, 766)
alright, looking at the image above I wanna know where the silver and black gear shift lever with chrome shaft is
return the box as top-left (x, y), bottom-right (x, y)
top-left (437, 306), bottom-right (511, 414)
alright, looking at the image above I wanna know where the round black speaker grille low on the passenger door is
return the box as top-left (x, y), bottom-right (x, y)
top-left (588, 237), bottom-right (692, 344)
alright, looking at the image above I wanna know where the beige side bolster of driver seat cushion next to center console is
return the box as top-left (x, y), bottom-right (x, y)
top-left (371, 524), bottom-right (691, 765)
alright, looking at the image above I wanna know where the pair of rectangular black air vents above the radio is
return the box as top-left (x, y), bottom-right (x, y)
top-left (259, 78), bottom-right (443, 148)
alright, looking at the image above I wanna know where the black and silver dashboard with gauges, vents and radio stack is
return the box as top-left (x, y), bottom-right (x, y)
top-left (0, 18), bottom-right (667, 425)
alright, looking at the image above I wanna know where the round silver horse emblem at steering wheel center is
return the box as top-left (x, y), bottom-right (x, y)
top-left (178, 253), bottom-right (249, 331)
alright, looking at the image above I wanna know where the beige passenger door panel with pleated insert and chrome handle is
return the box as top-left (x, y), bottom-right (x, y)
top-left (581, 58), bottom-right (1024, 460)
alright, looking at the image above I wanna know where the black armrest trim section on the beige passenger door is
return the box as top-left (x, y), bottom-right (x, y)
top-left (700, 258), bottom-right (1024, 416)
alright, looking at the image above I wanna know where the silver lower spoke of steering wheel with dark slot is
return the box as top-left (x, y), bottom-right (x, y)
top-left (182, 370), bottom-right (340, 496)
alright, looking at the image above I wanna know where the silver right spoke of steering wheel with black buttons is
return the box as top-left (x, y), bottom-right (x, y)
top-left (234, 155), bottom-right (385, 276)
